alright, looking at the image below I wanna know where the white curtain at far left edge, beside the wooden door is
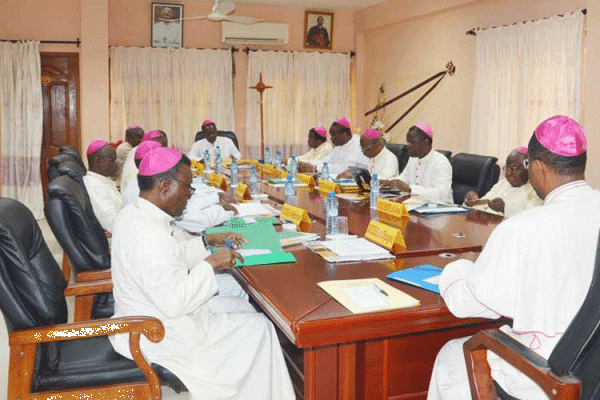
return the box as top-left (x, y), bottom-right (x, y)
top-left (0, 41), bottom-right (44, 219)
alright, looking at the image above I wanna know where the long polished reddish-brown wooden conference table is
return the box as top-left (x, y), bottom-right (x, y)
top-left (223, 173), bottom-right (507, 400)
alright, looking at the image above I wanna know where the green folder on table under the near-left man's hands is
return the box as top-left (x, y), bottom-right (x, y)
top-left (206, 222), bottom-right (296, 267)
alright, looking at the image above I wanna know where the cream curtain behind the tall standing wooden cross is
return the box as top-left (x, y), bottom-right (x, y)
top-left (246, 51), bottom-right (350, 158)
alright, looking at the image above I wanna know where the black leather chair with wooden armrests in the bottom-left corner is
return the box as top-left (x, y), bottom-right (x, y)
top-left (0, 198), bottom-right (185, 400)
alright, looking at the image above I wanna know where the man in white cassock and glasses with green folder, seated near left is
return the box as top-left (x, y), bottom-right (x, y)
top-left (111, 148), bottom-right (295, 400)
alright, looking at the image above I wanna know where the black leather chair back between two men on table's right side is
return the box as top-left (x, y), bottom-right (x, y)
top-left (451, 153), bottom-right (498, 204)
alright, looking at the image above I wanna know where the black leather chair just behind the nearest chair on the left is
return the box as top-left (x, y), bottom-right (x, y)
top-left (44, 175), bottom-right (114, 321)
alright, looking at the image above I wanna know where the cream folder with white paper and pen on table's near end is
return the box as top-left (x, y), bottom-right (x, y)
top-left (318, 278), bottom-right (419, 314)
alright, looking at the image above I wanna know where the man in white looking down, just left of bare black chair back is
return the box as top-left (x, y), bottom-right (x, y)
top-left (382, 122), bottom-right (454, 203)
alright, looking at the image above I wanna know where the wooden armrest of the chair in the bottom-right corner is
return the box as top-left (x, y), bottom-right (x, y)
top-left (463, 329), bottom-right (581, 400)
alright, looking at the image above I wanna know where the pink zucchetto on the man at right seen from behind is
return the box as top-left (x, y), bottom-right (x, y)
top-left (535, 115), bottom-right (587, 157)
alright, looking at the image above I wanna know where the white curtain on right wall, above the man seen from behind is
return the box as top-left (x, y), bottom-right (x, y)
top-left (470, 11), bottom-right (584, 162)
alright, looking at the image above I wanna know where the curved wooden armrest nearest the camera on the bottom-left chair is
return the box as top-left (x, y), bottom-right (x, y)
top-left (9, 317), bottom-right (165, 346)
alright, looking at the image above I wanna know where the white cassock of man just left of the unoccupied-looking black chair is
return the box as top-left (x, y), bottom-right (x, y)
top-left (397, 150), bottom-right (454, 203)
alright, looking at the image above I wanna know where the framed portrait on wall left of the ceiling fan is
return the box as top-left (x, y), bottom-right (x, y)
top-left (152, 3), bottom-right (183, 47)
